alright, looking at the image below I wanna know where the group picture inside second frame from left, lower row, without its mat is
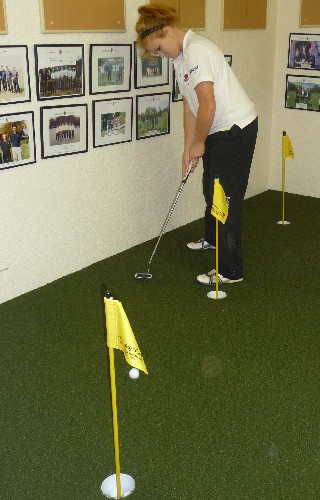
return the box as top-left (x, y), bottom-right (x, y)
top-left (49, 115), bottom-right (80, 146)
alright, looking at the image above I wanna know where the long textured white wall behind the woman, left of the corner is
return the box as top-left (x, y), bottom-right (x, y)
top-left (0, 0), bottom-right (278, 303)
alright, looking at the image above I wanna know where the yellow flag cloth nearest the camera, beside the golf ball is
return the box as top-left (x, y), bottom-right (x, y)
top-left (104, 298), bottom-right (148, 374)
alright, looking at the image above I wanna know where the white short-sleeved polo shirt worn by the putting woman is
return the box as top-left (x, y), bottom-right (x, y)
top-left (173, 30), bottom-right (257, 134)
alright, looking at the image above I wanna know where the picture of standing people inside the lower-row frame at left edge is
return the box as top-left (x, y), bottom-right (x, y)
top-left (0, 121), bottom-right (30, 168)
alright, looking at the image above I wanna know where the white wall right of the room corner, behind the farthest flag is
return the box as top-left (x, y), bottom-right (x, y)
top-left (269, 0), bottom-right (320, 197)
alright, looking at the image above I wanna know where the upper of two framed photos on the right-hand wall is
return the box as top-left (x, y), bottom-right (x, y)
top-left (288, 33), bottom-right (320, 70)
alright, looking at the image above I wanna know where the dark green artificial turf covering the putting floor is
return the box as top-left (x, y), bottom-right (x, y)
top-left (0, 191), bottom-right (320, 500)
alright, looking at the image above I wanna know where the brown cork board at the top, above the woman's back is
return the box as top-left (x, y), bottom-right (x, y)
top-left (223, 0), bottom-right (267, 30)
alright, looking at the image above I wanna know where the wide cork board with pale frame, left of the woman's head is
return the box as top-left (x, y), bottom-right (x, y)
top-left (40, 0), bottom-right (125, 33)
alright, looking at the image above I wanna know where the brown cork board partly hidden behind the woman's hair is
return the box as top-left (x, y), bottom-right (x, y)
top-left (149, 0), bottom-right (206, 29)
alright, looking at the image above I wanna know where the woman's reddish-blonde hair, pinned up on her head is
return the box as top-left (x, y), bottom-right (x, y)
top-left (136, 3), bottom-right (178, 55)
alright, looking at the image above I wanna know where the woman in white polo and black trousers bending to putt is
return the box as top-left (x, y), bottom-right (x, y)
top-left (136, 5), bottom-right (258, 285)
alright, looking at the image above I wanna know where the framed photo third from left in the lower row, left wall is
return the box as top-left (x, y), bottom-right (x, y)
top-left (92, 97), bottom-right (133, 148)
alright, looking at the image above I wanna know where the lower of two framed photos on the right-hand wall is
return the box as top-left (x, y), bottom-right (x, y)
top-left (285, 75), bottom-right (320, 111)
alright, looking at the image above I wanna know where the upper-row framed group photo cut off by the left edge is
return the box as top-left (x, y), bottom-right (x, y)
top-left (0, 45), bottom-right (31, 104)
